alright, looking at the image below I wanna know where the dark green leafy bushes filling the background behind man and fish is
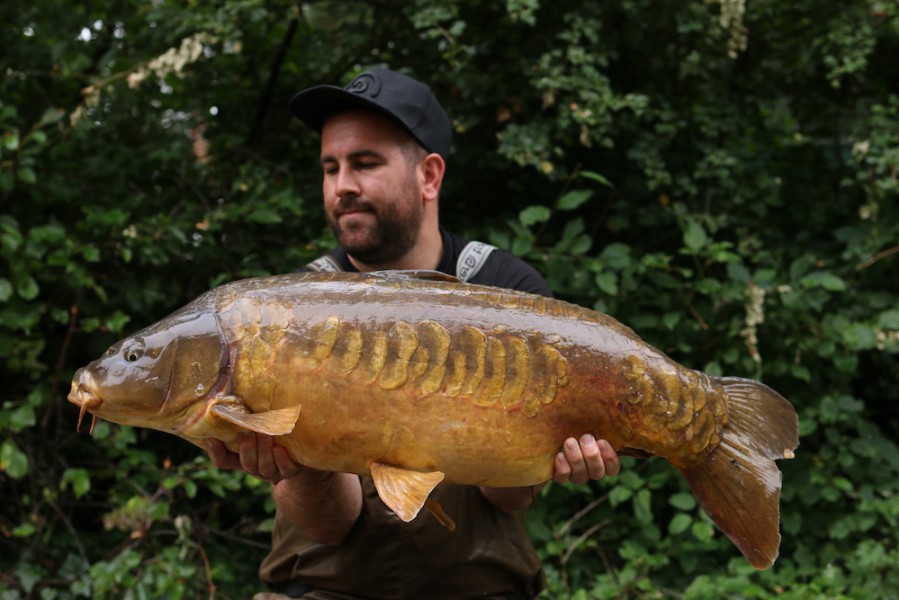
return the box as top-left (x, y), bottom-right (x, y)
top-left (0, 0), bottom-right (899, 599)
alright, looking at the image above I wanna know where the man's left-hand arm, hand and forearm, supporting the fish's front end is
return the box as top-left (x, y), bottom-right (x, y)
top-left (207, 434), bottom-right (362, 544)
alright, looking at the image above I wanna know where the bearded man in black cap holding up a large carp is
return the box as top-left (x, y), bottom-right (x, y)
top-left (209, 69), bottom-right (620, 599)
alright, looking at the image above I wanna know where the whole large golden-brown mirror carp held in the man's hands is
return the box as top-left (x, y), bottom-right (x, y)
top-left (69, 271), bottom-right (798, 568)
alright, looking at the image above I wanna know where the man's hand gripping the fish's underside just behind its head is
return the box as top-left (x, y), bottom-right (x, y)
top-left (206, 433), bottom-right (307, 483)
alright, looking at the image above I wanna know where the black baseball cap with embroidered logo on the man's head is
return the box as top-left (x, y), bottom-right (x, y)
top-left (288, 69), bottom-right (453, 160)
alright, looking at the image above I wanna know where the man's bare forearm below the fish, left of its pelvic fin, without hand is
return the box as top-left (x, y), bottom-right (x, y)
top-left (272, 469), bottom-right (362, 545)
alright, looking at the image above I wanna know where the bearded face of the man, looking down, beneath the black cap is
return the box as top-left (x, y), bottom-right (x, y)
top-left (321, 110), bottom-right (424, 265)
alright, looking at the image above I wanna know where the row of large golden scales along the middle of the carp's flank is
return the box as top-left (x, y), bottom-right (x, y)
top-left (284, 315), bottom-right (568, 416)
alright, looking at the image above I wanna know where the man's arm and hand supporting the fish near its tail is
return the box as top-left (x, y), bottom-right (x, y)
top-left (481, 434), bottom-right (621, 510)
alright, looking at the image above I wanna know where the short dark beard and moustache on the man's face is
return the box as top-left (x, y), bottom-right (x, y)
top-left (326, 187), bottom-right (424, 265)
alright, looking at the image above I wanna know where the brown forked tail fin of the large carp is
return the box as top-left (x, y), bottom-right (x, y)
top-left (679, 377), bottom-right (799, 569)
